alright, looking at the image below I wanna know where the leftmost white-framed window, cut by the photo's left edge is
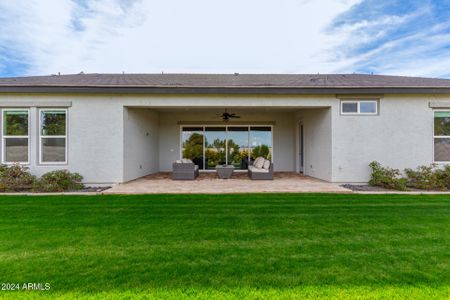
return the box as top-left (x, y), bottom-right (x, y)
top-left (2, 109), bottom-right (30, 164)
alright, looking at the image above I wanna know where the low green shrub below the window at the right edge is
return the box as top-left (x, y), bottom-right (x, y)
top-left (405, 164), bottom-right (450, 190)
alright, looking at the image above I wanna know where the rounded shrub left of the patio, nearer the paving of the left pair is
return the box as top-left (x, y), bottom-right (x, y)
top-left (33, 170), bottom-right (84, 192)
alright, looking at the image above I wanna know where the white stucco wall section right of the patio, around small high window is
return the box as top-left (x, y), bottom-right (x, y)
top-left (332, 95), bottom-right (435, 182)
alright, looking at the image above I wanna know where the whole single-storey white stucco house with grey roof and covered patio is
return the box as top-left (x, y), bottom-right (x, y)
top-left (0, 74), bottom-right (450, 184)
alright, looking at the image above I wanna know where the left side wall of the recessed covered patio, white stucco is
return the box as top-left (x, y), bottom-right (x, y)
top-left (123, 108), bottom-right (159, 181)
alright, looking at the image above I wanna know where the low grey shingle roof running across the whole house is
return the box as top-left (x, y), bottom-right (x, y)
top-left (0, 74), bottom-right (450, 92)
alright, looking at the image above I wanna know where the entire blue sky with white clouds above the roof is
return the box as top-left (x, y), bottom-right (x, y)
top-left (0, 0), bottom-right (450, 78)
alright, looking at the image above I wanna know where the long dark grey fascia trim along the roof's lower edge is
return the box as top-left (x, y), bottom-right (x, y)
top-left (0, 86), bottom-right (450, 95)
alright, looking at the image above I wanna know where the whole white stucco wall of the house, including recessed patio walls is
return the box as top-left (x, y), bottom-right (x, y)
top-left (0, 94), bottom-right (450, 184)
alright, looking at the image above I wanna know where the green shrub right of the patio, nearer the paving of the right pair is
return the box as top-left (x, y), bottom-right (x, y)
top-left (369, 161), bottom-right (407, 191)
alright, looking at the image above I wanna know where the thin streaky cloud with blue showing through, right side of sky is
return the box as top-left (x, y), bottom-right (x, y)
top-left (333, 2), bottom-right (450, 77)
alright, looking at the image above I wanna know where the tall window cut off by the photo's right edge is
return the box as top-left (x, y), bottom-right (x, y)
top-left (434, 111), bottom-right (450, 162)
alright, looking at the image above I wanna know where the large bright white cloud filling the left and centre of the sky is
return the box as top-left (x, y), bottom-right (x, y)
top-left (0, 0), bottom-right (359, 74)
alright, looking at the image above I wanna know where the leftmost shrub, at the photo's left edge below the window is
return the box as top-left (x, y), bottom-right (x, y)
top-left (0, 164), bottom-right (36, 192)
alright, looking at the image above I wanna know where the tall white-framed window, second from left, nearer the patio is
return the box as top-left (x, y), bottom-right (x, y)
top-left (39, 109), bottom-right (67, 164)
